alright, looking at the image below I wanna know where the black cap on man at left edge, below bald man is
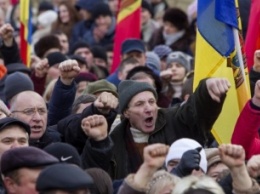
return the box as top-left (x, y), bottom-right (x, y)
top-left (0, 117), bottom-right (31, 135)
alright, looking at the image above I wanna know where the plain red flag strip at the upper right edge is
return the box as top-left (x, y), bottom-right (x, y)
top-left (245, 0), bottom-right (260, 70)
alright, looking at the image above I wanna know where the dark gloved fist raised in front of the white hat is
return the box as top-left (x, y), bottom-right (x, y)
top-left (171, 147), bottom-right (202, 177)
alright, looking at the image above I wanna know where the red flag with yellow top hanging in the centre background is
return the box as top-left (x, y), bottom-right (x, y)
top-left (110, 0), bottom-right (141, 73)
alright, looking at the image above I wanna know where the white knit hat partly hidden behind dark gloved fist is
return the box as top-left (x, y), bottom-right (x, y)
top-left (165, 138), bottom-right (207, 173)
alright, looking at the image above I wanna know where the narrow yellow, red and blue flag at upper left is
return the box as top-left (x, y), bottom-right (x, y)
top-left (20, 0), bottom-right (32, 67)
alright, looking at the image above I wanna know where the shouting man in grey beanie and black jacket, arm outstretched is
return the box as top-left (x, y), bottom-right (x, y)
top-left (82, 78), bottom-right (230, 179)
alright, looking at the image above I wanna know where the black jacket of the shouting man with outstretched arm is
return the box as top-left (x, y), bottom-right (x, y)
top-left (109, 80), bottom-right (225, 179)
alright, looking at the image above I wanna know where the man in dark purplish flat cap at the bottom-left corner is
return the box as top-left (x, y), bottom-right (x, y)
top-left (0, 147), bottom-right (58, 194)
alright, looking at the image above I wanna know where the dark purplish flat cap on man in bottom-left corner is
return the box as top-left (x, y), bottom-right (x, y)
top-left (0, 147), bottom-right (59, 175)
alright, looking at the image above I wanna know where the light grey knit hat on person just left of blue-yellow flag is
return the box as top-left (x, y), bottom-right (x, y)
top-left (166, 51), bottom-right (192, 72)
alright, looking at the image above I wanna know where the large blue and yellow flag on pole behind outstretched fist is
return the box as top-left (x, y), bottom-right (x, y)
top-left (194, 0), bottom-right (250, 143)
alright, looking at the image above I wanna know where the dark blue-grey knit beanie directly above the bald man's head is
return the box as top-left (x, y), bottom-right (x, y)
top-left (4, 72), bottom-right (34, 101)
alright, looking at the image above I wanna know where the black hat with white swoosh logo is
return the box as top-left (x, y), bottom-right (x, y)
top-left (44, 142), bottom-right (81, 167)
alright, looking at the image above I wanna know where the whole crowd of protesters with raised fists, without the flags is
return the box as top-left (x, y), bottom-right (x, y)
top-left (0, 0), bottom-right (260, 194)
